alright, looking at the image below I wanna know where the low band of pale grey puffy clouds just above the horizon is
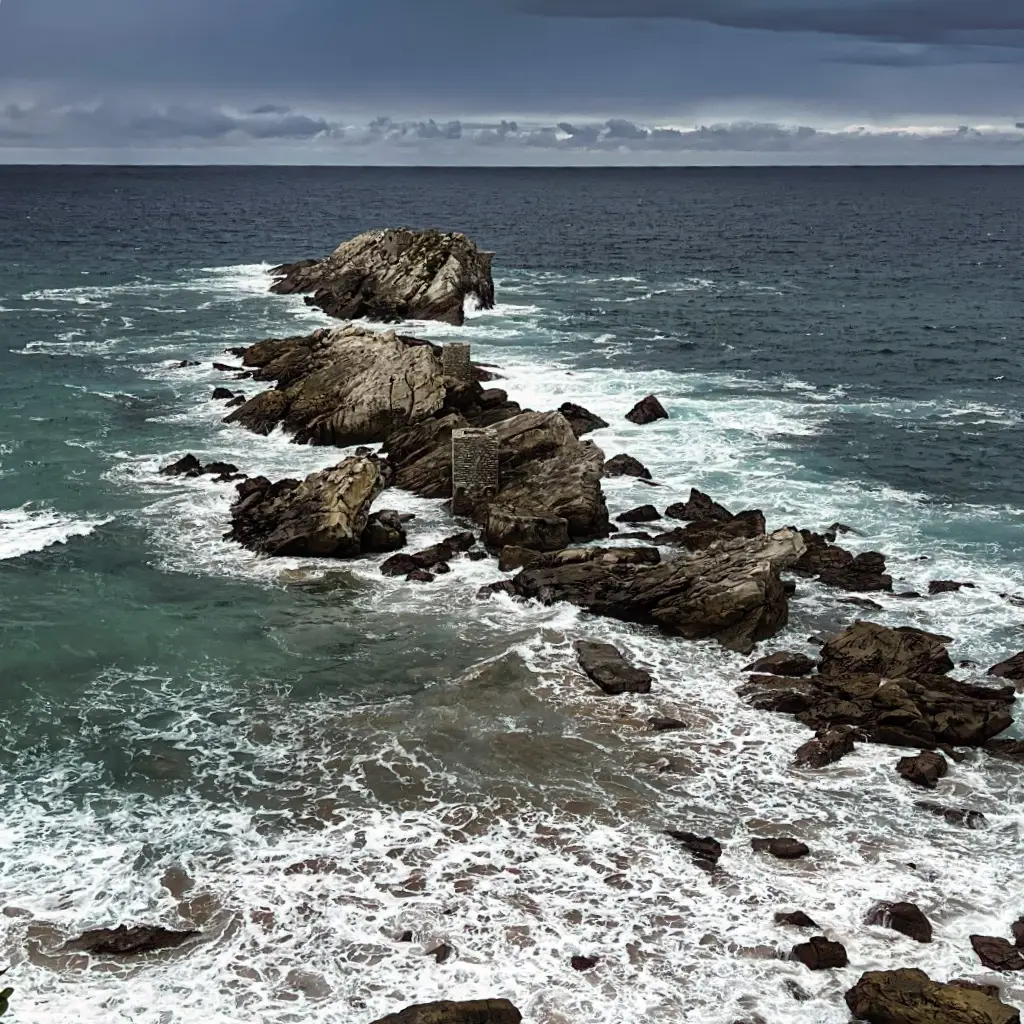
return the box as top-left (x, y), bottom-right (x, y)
top-left (0, 103), bottom-right (1024, 164)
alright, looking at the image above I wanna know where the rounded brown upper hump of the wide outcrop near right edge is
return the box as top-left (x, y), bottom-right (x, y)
top-left (819, 622), bottom-right (953, 679)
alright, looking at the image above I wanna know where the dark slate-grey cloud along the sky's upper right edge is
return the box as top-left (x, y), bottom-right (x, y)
top-left (519, 0), bottom-right (1024, 45)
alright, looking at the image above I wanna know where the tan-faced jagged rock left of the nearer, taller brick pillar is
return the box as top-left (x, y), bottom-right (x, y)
top-left (227, 458), bottom-right (385, 558)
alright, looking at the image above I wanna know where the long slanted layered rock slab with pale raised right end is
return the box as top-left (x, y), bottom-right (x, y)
top-left (513, 530), bottom-right (803, 653)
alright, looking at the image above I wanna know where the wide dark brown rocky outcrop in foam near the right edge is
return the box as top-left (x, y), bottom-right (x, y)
top-left (739, 623), bottom-right (1015, 750)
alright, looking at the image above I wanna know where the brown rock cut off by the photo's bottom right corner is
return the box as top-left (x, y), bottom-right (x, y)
top-left (846, 968), bottom-right (1020, 1024)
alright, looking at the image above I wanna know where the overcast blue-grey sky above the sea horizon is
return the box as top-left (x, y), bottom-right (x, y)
top-left (0, 0), bottom-right (1024, 165)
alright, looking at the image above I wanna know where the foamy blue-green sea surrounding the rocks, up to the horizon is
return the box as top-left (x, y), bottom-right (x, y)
top-left (0, 167), bottom-right (1024, 1024)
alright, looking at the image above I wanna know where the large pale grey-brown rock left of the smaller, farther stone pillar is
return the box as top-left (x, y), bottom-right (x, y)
top-left (224, 325), bottom-right (447, 447)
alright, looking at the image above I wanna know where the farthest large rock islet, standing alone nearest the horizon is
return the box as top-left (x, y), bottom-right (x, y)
top-left (270, 228), bottom-right (495, 325)
